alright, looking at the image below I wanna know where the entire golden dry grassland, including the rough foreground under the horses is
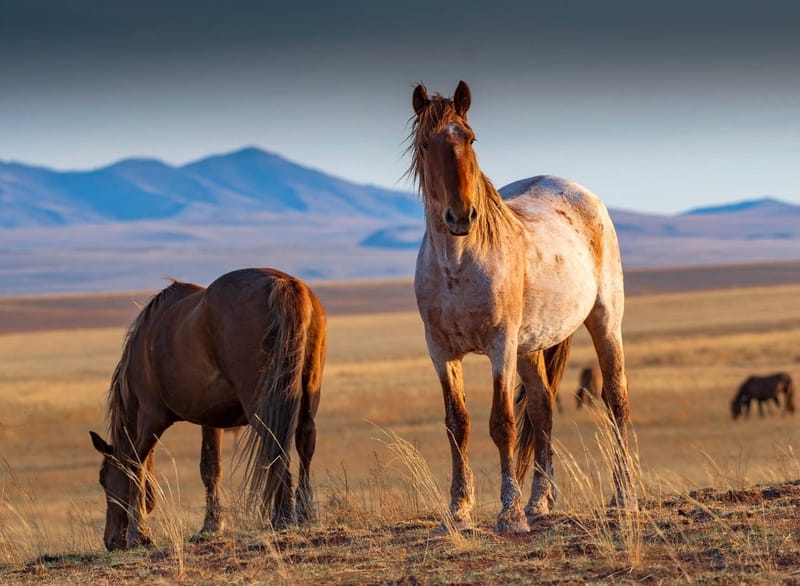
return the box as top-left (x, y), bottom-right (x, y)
top-left (0, 278), bottom-right (800, 583)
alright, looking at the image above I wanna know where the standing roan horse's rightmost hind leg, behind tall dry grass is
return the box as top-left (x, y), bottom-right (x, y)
top-left (585, 303), bottom-right (636, 509)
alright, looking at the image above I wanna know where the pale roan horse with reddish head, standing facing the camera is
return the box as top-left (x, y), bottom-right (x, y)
top-left (409, 81), bottom-right (636, 533)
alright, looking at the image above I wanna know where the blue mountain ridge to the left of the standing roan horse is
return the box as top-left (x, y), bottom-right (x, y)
top-left (0, 147), bottom-right (421, 228)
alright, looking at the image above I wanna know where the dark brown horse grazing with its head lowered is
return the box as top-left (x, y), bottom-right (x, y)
top-left (91, 269), bottom-right (327, 550)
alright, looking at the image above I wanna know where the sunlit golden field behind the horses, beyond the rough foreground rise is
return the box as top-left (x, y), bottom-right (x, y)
top-left (0, 278), bottom-right (800, 582)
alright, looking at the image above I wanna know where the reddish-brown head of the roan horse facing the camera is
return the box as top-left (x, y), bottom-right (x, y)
top-left (409, 81), bottom-right (483, 236)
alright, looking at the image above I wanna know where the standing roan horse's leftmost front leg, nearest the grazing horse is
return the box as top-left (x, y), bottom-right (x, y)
top-left (431, 351), bottom-right (475, 529)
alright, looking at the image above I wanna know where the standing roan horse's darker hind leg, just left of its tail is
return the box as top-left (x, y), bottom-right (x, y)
top-left (517, 352), bottom-right (556, 523)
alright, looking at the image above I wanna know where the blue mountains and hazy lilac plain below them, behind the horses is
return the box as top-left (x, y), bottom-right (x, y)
top-left (0, 152), bottom-right (800, 295)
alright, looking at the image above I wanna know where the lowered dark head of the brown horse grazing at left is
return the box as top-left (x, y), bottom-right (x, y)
top-left (89, 431), bottom-right (130, 551)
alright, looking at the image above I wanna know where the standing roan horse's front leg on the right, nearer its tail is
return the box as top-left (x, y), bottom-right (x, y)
top-left (489, 342), bottom-right (528, 533)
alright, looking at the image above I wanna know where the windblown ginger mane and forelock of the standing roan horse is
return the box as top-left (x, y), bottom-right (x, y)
top-left (405, 93), bottom-right (513, 249)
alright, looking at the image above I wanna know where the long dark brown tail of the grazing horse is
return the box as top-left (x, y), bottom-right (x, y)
top-left (241, 275), bottom-right (313, 521)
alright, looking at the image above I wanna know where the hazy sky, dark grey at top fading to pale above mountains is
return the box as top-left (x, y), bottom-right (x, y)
top-left (0, 0), bottom-right (800, 213)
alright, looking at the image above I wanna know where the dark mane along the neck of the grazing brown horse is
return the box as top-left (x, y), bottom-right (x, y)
top-left (107, 279), bottom-right (202, 450)
